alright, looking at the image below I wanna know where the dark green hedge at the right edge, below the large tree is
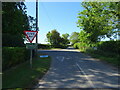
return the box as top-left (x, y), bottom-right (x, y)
top-left (97, 41), bottom-right (120, 53)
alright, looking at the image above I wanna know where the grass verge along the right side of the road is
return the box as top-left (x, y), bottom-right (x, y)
top-left (85, 49), bottom-right (120, 67)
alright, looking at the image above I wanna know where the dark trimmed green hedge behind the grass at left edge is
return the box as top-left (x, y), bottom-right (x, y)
top-left (2, 47), bottom-right (30, 70)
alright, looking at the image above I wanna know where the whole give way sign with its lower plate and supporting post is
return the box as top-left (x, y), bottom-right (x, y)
top-left (24, 31), bottom-right (38, 68)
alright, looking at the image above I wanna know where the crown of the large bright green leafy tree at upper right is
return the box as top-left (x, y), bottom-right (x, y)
top-left (77, 2), bottom-right (118, 42)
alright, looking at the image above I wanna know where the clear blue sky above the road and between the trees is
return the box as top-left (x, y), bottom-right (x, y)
top-left (25, 2), bottom-right (84, 44)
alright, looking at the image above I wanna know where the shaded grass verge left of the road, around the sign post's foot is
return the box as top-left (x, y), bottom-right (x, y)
top-left (2, 54), bottom-right (51, 89)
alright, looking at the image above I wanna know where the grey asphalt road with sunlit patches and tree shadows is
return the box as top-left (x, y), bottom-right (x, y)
top-left (36, 49), bottom-right (120, 88)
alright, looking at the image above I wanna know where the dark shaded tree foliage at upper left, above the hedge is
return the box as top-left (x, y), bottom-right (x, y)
top-left (2, 2), bottom-right (35, 46)
